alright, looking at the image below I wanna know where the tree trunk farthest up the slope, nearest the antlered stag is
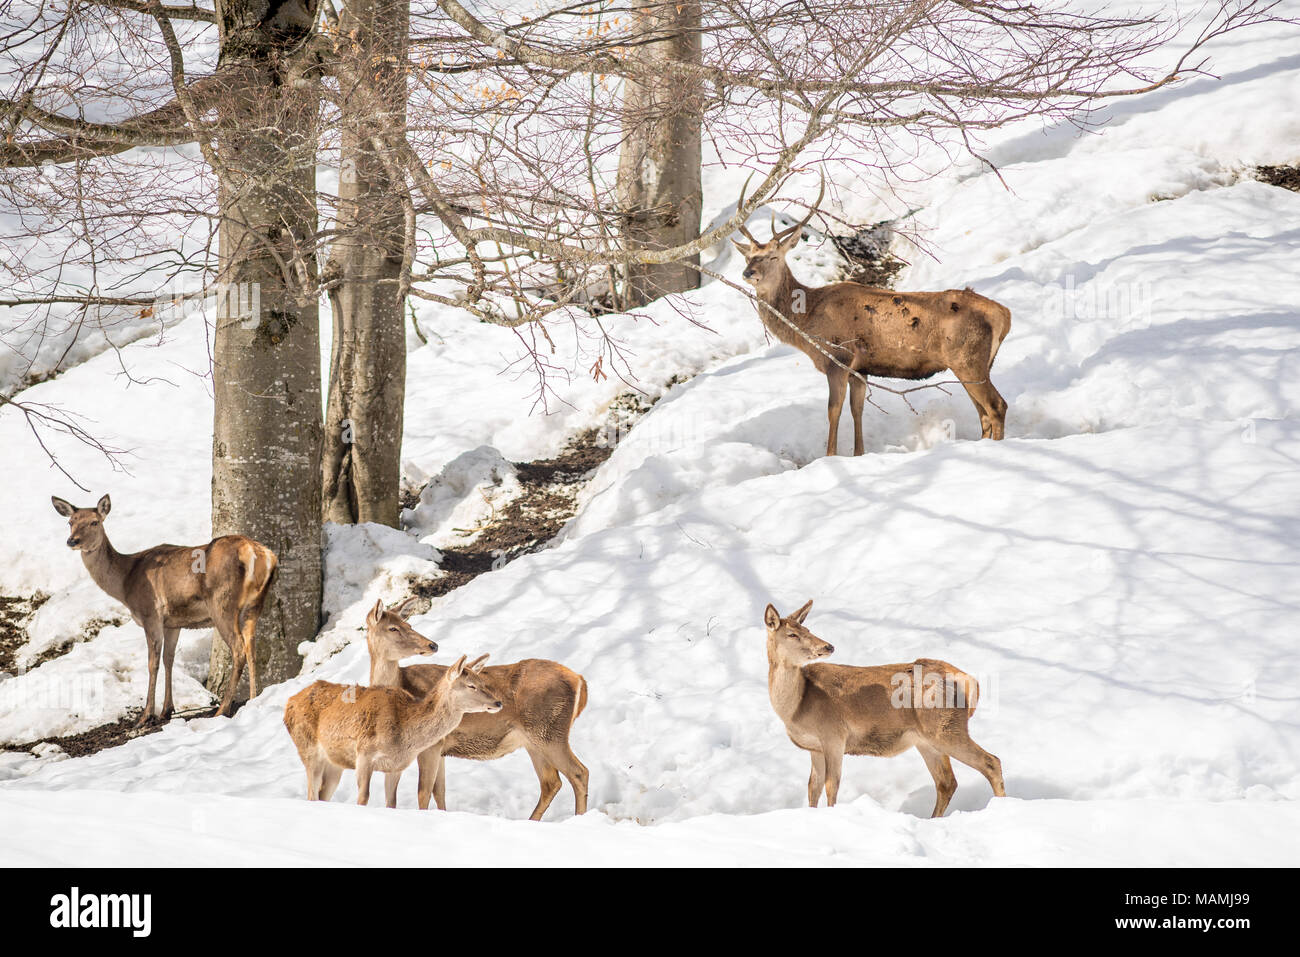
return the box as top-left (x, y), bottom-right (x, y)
top-left (618, 3), bottom-right (703, 306)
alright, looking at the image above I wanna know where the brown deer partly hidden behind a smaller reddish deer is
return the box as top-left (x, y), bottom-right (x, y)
top-left (365, 598), bottom-right (588, 820)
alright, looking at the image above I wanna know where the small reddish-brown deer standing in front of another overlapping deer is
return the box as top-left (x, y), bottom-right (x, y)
top-left (285, 655), bottom-right (502, 807)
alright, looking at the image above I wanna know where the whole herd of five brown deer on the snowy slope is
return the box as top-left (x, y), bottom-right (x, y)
top-left (43, 182), bottom-right (1010, 820)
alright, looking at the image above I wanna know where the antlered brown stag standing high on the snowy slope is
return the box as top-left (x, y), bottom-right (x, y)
top-left (732, 179), bottom-right (1011, 455)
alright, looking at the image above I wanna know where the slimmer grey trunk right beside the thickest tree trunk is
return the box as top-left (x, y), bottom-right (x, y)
top-left (321, 0), bottom-right (410, 527)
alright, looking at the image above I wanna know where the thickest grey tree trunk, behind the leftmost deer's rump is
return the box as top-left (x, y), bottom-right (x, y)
top-left (208, 0), bottom-right (321, 690)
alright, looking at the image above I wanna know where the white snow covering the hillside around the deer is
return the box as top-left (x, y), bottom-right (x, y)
top-left (0, 11), bottom-right (1300, 865)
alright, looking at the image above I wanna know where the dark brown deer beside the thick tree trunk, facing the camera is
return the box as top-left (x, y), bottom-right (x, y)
top-left (51, 495), bottom-right (277, 726)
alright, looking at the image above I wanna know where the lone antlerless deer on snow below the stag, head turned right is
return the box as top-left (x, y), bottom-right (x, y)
top-left (763, 601), bottom-right (1006, 818)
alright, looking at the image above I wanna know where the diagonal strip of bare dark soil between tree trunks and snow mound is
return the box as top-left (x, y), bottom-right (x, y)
top-left (413, 429), bottom-right (614, 598)
